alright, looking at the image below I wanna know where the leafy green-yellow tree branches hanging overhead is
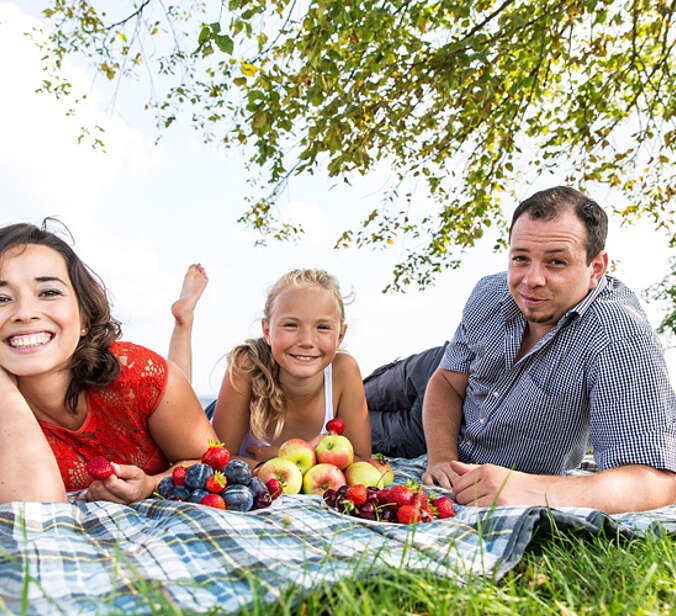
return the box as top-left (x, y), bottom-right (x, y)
top-left (38, 0), bottom-right (676, 289)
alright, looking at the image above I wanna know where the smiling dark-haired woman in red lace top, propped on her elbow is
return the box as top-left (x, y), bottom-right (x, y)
top-left (0, 224), bottom-right (215, 503)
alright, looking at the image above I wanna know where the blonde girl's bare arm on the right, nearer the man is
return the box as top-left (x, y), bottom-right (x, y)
top-left (333, 353), bottom-right (371, 458)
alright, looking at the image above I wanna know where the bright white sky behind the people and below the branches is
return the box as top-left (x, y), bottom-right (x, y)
top-left (0, 0), bottom-right (676, 397)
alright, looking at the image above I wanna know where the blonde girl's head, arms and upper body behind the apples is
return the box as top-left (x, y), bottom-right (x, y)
top-left (206, 269), bottom-right (371, 466)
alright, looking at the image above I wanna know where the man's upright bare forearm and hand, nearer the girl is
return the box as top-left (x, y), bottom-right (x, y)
top-left (422, 368), bottom-right (467, 488)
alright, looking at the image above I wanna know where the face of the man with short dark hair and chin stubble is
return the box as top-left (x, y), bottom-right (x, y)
top-left (508, 209), bottom-right (608, 331)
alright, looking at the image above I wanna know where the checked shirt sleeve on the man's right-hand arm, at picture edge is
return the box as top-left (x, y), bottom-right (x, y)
top-left (589, 334), bottom-right (676, 471)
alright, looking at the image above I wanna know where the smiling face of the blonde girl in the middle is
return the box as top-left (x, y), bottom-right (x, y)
top-left (263, 286), bottom-right (346, 378)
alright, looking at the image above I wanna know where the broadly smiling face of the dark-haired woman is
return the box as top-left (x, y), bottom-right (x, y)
top-left (0, 244), bottom-right (82, 377)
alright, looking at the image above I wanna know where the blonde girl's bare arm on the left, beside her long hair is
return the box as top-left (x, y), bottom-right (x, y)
top-left (213, 367), bottom-right (251, 462)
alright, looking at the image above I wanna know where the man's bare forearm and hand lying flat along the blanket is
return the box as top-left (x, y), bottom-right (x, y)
top-left (450, 461), bottom-right (676, 513)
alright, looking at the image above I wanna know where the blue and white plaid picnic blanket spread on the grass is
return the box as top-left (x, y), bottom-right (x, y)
top-left (0, 456), bottom-right (676, 616)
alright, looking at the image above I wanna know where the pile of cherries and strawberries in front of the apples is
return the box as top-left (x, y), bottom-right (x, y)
top-left (323, 484), bottom-right (454, 524)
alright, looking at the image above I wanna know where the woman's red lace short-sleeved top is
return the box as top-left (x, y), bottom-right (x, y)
top-left (40, 342), bottom-right (169, 490)
